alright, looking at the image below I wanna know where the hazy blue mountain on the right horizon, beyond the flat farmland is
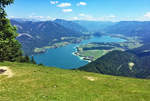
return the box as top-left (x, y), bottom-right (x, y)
top-left (105, 21), bottom-right (150, 42)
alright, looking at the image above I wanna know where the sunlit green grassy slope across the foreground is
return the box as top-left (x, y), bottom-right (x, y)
top-left (0, 62), bottom-right (150, 101)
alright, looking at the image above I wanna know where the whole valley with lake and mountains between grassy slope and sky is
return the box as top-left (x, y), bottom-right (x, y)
top-left (11, 19), bottom-right (150, 78)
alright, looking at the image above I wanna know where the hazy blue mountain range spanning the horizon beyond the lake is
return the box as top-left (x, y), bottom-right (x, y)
top-left (11, 19), bottom-right (150, 53)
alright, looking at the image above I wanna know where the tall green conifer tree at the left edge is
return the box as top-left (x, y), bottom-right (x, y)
top-left (0, 0), bottom-right (22, 62)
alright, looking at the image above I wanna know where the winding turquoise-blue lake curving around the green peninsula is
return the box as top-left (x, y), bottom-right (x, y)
top-left (34, 36), bottom-right (126, 69)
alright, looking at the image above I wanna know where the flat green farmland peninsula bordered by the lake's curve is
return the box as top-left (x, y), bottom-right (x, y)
top-left (75, 34), bottom-right (143, 61)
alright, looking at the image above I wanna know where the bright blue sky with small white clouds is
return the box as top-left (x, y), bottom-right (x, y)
top-left (6, 0), bottom-right (150, 21)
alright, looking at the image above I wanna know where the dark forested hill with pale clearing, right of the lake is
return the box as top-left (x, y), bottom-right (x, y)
top-left (79, 51), bottom-right (150, 78)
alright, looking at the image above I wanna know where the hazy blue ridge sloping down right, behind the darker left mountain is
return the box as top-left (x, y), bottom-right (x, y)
top-left (53, 19), bottom-right (87, 33)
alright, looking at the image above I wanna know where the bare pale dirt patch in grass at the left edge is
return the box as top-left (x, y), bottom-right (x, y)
top-left (0, 66), bottom-right (14, 78)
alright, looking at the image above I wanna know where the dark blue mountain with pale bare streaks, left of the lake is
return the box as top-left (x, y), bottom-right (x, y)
top-left (11, 20), bottom-right (83, 54)
